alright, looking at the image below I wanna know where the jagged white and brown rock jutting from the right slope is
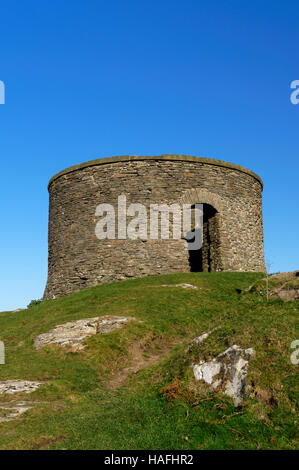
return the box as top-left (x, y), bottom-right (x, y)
top-left (192, 344), bottom-right (255, 406)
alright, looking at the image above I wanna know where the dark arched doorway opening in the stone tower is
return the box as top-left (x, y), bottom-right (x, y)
top-left (187, 204), bottom-right (221, 272)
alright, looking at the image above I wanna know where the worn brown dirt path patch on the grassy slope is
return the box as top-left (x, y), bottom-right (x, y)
top-left (106, 338), bottom-right (186, 390)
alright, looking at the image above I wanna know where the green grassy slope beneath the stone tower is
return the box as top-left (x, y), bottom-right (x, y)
top-left (0, 273), bottom-right (298, 449)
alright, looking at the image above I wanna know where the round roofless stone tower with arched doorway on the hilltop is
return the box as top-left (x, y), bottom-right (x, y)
top-left (44, 155), bottom-right (265, 299)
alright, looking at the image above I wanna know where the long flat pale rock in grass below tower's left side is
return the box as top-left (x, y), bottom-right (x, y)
top-left (34, 315), bottom-right (136, 351)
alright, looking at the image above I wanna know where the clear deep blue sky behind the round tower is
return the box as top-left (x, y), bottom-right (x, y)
top-left (0, 0), bottom-right (299, 310)
